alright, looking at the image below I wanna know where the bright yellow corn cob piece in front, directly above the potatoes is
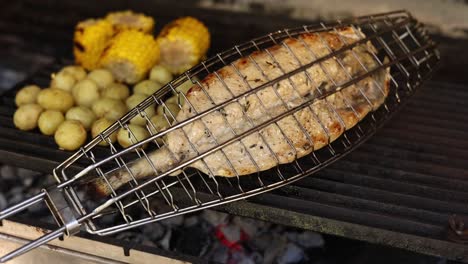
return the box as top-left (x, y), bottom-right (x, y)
top-left (100, 30), bottom-right (159, 84)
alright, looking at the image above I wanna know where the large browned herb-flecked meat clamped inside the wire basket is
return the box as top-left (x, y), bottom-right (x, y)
top-left (92, 27), bottom-right (390, 195)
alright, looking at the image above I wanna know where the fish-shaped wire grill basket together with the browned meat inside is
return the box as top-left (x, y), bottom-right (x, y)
top-left (0, 11), bottom-right (439, 262)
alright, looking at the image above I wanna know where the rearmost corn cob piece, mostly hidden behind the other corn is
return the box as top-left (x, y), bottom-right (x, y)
top-left (106, 10), bottom-right (154, 33)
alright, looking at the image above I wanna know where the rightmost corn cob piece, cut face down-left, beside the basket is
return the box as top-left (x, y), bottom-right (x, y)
top-left (157, 17), bottom-right (210, 74)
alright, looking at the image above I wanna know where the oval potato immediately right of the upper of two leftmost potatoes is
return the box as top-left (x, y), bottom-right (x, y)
top-left (37, 88), bottom-right (74, 112)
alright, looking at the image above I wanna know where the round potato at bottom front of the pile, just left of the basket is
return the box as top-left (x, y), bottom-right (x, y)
top-left (54, 120), bottom-right (86, 150)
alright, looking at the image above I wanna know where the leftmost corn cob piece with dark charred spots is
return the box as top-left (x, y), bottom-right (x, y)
top-left (73, 19), bottom-right (114, 70)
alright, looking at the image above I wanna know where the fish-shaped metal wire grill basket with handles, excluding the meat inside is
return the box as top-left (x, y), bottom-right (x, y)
top-left (0, 11), bottom-right (439, 262)
